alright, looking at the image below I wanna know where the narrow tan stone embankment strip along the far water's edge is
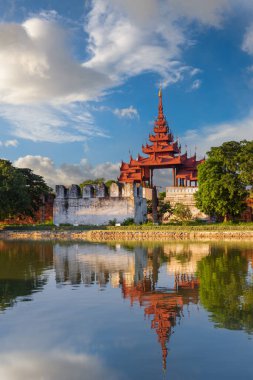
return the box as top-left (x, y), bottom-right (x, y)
top-left (0, 229), bottom-right (253, 242)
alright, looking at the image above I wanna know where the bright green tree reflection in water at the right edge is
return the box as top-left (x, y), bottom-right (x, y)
top-left (198, 248), bottom-right (253, 332)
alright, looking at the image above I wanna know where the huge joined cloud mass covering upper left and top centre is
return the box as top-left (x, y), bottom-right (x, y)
top-left (0, 0), bottom-right (231, 104)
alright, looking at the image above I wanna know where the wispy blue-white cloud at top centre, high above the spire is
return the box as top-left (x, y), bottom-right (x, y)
top-left (84, 0), bottom-right (229, 83)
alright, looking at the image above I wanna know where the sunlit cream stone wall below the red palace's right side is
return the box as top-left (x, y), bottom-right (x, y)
top-left (165, 186), bottom-right (208, 219)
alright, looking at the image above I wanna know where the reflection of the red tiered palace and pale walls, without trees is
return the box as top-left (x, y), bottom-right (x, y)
top-left (54, 243), bottom-right (209, 368)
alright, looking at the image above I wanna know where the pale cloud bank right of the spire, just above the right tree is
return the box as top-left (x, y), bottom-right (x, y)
top-left (182, 111), bottom-right (253, 156)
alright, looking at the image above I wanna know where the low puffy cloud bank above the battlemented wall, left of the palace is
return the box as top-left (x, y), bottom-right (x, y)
top-left (13, 155), bottom-right (120, 187)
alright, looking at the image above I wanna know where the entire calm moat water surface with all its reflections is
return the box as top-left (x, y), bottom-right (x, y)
top-left (0, 241), bottom-right (253, 380)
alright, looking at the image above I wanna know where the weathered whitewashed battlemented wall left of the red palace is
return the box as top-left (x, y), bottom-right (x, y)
top-left (53, 183), bottom-right (147, 225)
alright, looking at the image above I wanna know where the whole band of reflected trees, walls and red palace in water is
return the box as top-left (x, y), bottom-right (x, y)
top-left (0, 242), bottom-right (253, 368)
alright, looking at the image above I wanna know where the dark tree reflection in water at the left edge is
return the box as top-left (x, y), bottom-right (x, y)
top-left (0, 241), bottom-right (53, 310)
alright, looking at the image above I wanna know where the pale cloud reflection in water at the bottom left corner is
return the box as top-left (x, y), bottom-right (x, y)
top-left (0, 352), bottom-right (122, 380)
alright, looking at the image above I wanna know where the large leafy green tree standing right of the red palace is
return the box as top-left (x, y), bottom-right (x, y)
top-left (195, 141), bottom-right (253, 221)
